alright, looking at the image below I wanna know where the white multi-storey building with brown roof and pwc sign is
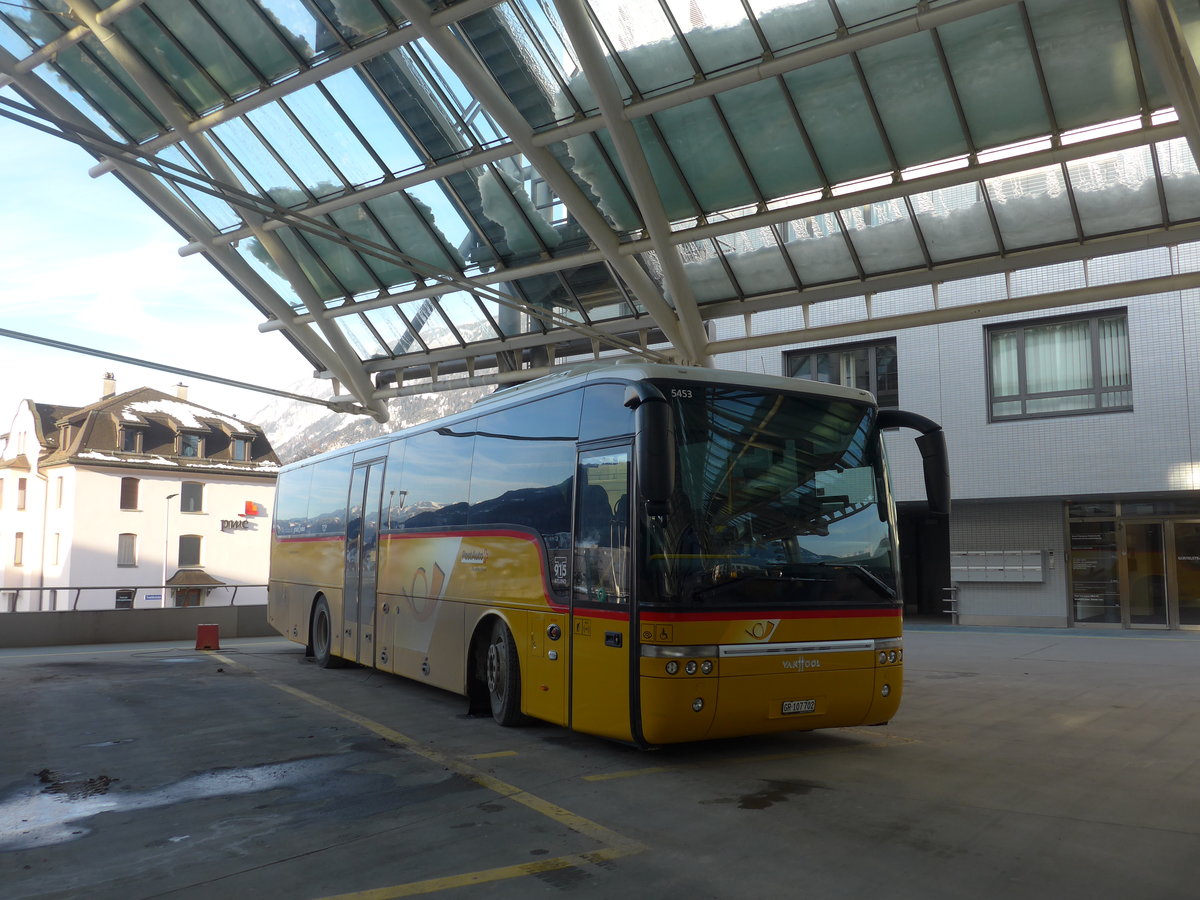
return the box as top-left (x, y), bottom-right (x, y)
top-left (0, 376), bottom-right (278, 612)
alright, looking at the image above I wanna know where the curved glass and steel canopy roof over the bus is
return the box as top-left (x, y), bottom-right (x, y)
top-left (0, 0), bottom-right (1200, 419)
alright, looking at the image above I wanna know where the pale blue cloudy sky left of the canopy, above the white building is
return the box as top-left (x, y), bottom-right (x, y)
top-left (0, 112), bottom-right (322, 434)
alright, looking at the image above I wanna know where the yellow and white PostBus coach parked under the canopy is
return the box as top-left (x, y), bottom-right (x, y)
top-left (269, 362), bottom-right (949, 746)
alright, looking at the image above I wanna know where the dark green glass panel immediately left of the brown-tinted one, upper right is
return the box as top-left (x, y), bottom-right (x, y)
top-left (937, 5), bottom-right (1050, 148)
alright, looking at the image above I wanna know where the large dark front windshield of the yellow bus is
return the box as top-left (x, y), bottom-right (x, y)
top-left (643, 383), bottom-right (900, 608)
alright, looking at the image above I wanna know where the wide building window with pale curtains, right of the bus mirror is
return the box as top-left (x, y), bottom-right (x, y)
top-left (988, 310), bottom-right (1133, 421)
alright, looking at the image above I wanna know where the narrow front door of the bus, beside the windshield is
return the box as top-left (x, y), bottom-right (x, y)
top-left (570, 446), bottom-right (632, 740)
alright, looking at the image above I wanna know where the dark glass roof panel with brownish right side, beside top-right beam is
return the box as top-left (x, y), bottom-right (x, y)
top-left (1026, 0), bottom-right (1141, 130)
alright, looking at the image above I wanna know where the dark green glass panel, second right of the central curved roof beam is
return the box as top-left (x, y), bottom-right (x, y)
top-left (654, 98), bottom-right (757, 218)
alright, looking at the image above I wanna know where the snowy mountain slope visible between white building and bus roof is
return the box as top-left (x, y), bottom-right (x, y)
top-left (251, 379), bottom-right (492, 463)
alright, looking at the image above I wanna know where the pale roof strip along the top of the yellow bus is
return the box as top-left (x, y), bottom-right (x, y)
top-left (283, 360), bottom-right (875, 469)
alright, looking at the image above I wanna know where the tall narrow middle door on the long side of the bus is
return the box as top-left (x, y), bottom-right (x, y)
top-left (343, 460), bottom-right (383, 666)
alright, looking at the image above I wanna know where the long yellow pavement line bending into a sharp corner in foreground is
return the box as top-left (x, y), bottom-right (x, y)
top-left (212, 652), bottom-right (646, 900)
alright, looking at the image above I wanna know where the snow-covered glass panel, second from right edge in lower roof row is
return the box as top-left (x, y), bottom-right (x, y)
top-left (1067, 146), bottom-right (1163, 235)
